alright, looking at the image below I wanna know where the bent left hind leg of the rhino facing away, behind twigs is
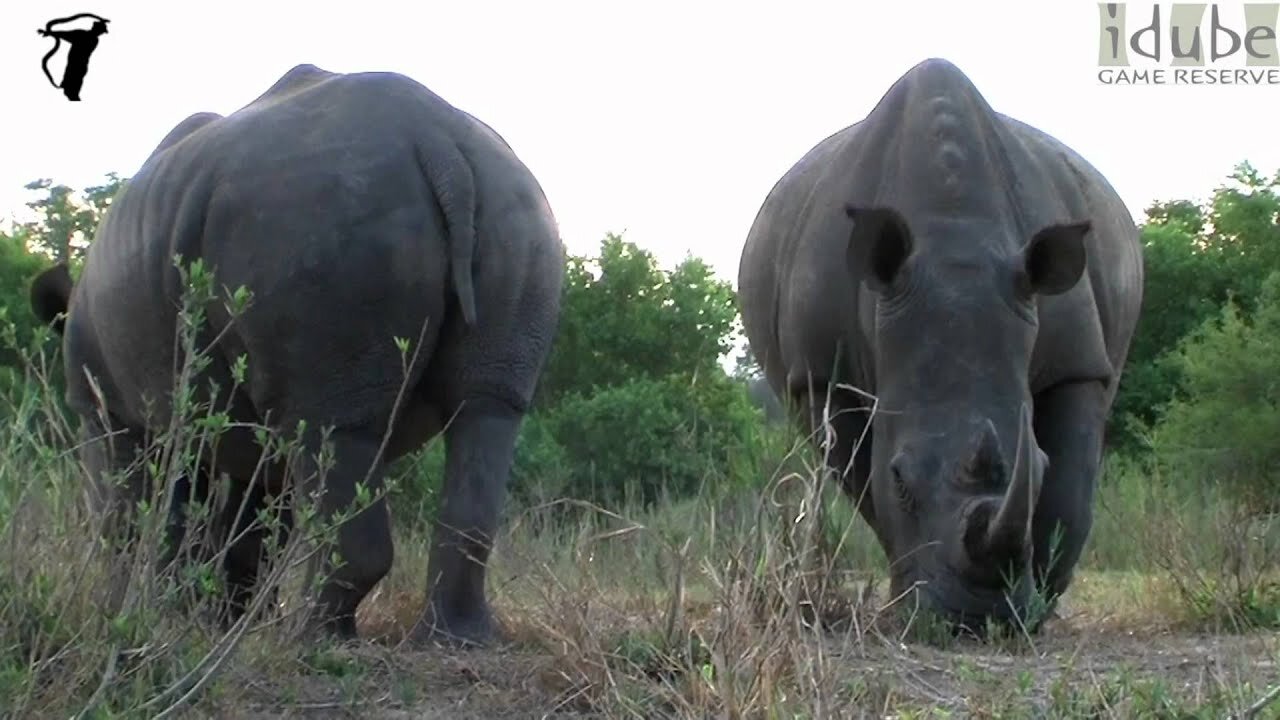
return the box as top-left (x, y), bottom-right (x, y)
top-left (295, 429), bottom-right (394, 639)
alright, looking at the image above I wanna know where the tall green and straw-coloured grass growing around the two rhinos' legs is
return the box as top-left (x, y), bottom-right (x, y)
top-left (0, 279), bottom-right (1280, 717)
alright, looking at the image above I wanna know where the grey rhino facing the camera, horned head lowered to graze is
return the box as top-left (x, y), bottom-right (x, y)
top-left (739, 59), bottom-right (1143, 633)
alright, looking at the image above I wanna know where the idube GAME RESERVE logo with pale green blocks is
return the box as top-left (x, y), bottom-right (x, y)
top-left (1097, 3), bottom-right (1280, 86)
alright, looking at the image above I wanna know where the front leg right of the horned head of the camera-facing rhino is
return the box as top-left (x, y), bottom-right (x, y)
top-left (1032, 382), bottom-right (1107, 609)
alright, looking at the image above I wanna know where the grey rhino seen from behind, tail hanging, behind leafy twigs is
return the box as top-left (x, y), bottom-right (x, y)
top-left (32, 65), bottom-right (564, 642)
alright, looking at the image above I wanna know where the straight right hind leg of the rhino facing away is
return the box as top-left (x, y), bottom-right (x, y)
top-left (415, 397), bottom-right (522, 644)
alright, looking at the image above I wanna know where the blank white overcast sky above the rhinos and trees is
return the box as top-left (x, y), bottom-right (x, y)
top-left (0, 0), bottom-right (1280, 281)
